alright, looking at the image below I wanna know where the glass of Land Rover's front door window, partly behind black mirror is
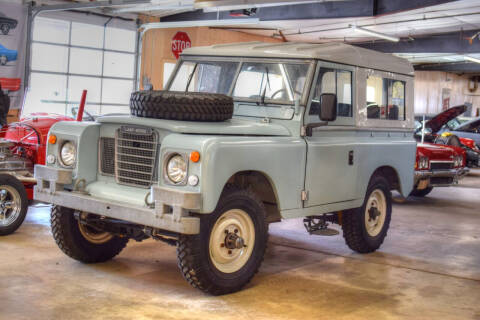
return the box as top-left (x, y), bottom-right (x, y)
top-left (309, 68), bottom-right (352, 117)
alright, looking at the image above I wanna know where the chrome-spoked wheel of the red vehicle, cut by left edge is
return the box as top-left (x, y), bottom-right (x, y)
top-left (0, 174), bottom-right (28, 236)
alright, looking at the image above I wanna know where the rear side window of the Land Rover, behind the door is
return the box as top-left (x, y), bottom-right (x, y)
top-left (367, 76), bottom-right (405, 120)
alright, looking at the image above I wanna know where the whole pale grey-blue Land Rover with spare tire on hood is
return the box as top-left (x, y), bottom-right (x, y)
top-left (35, 43), bottom-right (416, 294)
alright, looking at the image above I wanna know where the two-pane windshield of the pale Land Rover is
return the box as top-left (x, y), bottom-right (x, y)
top-left (169, 61), bottom-right (310, 104)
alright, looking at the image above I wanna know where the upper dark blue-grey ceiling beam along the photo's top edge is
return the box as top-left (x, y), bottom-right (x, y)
top-left (162, 0), bottom-right (457, 22)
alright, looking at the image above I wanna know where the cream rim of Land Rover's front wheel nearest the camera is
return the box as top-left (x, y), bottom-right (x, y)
top-left (209, 209), bottom-right (255, 273)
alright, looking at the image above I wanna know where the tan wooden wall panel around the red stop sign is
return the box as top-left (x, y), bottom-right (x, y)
top-left (140, 27), bottom-right (280, 90)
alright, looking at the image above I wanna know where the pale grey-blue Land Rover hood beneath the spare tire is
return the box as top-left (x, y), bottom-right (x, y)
top-left (97, 116), bottom-right (290, 136)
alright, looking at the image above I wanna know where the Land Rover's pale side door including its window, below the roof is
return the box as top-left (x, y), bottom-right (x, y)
top-left (304, 63), bottom-right (358, 207)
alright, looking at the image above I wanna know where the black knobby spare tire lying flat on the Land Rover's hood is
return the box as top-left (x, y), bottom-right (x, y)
top-left (130, 90), bottom-right (233, 121)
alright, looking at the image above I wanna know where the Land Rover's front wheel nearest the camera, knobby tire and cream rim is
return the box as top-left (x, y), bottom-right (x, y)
top-left (177, 187), bottom-right (268, 295)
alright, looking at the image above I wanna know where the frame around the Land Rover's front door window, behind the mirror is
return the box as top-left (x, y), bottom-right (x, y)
top-left (304, 60), bottom-right (357, 126)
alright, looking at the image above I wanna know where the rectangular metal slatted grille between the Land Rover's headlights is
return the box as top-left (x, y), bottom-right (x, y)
top-left (115, 129), bottom-right (158, 188)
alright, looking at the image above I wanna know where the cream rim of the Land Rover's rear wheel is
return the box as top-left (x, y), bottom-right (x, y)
top-left (365, 189), bottom-right (387, 237)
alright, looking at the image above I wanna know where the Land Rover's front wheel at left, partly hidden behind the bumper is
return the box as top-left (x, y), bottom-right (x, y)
top-left (50, 206), bottom-right (128, 263)
